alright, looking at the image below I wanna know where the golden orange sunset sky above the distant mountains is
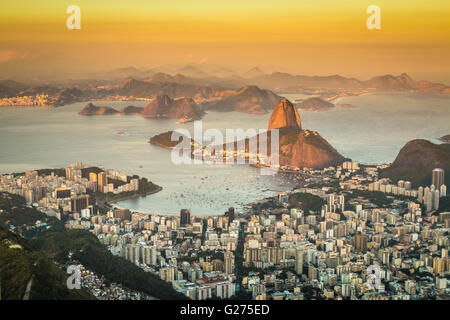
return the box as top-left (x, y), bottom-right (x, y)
top-left (0, 0), bottom-right (450, 85)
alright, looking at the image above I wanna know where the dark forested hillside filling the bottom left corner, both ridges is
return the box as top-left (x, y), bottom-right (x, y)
top-left (0, 192), bottom-right (186, 300)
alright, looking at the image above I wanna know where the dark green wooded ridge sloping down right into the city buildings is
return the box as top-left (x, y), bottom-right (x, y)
top-left (39, 230), bottom-right (186, 299)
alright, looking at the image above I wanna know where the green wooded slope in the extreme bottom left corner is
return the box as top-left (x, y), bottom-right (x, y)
top-left (0, 228), bottom-right (95, 300)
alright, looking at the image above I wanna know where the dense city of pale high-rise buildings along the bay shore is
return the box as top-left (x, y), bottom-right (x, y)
top-left (0, 161), bottom-right (450, 300)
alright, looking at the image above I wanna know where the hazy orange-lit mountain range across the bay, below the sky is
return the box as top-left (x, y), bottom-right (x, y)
top-left (0, 66), bottom-right (450, 114)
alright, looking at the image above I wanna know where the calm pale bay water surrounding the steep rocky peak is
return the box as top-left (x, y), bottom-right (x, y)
top-left (0, 93), bottom-right (450, 214)
